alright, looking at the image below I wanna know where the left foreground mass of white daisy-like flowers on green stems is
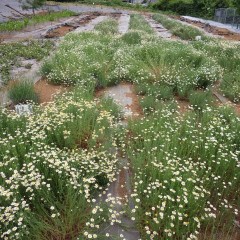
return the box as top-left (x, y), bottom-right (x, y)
top-left (0, 85), bottom-right (117, 240)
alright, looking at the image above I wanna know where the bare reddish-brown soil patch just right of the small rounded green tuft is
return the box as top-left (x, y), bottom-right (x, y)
top-left (34, 79), bottom-right (68, 103)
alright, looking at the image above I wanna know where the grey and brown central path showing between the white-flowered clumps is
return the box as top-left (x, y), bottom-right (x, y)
top-left (97, 83), bottom-right (140, 240)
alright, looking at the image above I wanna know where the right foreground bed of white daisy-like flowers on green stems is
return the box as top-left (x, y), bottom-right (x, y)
top-left (126, 107), bottom-right (240, 240)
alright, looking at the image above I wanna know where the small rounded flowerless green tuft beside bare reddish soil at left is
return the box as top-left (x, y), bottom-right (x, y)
top-left (8, 80), bottom-right (38, 104)
